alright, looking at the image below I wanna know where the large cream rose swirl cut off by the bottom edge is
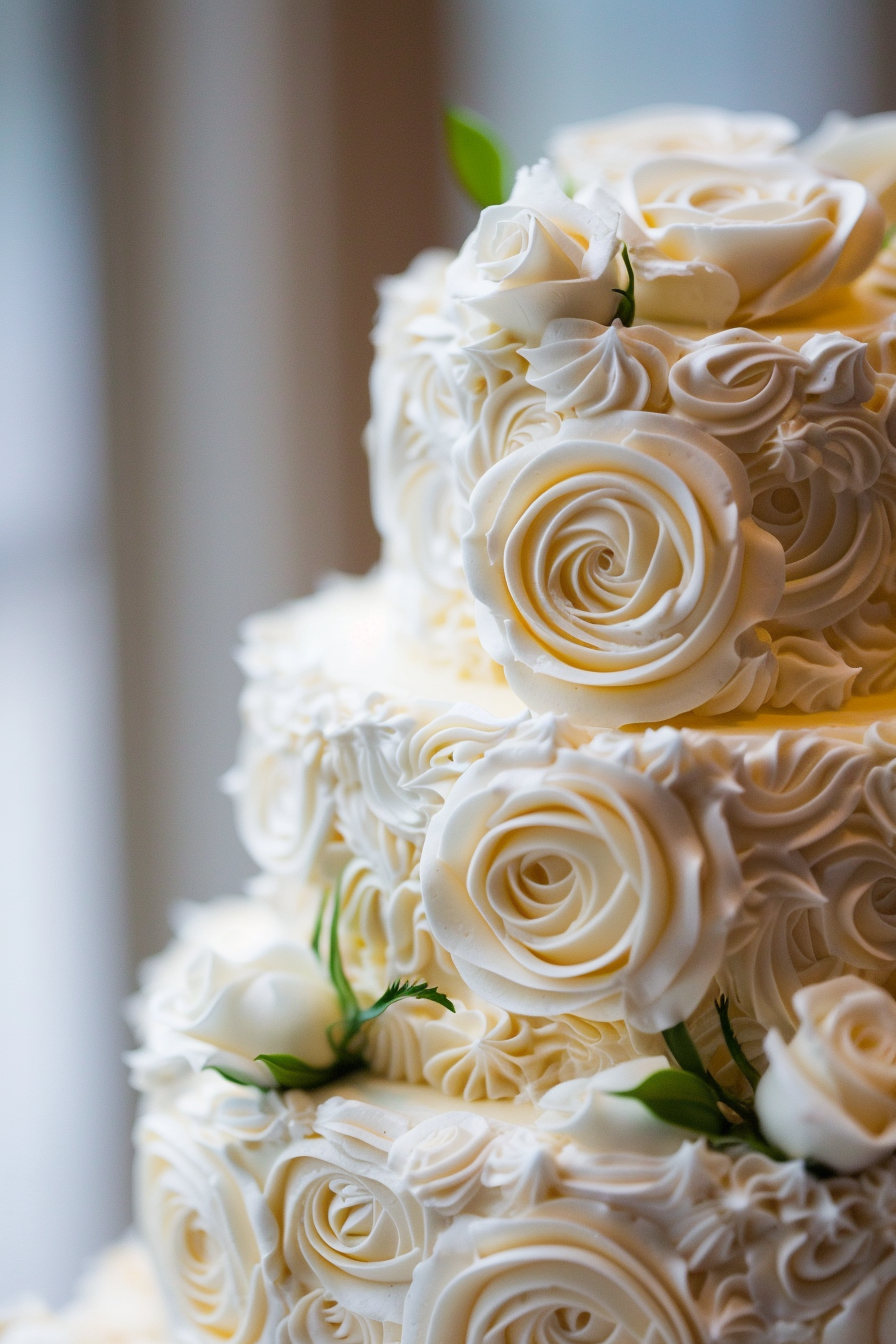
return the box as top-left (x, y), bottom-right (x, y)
top-left (402, 1199), bottom-right (704, 1344)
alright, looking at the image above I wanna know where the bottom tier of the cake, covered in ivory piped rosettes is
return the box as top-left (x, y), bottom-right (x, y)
top-left (131, 1074), bottom-right (896, 1344)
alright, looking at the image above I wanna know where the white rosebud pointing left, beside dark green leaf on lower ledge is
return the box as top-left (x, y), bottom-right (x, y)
top-left (536, 1055), bottom-right (688, 1157)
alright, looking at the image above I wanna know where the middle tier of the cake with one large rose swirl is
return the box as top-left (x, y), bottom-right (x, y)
top-left (220, 575), bottom-right (896, 1099)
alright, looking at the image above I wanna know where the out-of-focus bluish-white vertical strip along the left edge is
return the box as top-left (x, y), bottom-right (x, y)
top-left (0, 0), bottom-right (129, 1301)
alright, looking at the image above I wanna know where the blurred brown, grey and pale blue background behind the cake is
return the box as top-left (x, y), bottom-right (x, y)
top-left (0, 0), bottom-right (896, 1304)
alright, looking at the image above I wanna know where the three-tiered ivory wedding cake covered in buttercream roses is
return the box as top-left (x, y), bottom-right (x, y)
top-left (8, 109), bottom-right (896, 1344)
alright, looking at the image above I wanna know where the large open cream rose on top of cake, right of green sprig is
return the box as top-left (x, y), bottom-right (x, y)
top-left (614, 155), bottom-right (884, 327)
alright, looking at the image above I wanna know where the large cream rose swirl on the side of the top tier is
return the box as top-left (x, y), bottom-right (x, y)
top-left (463, 411), bottom-right (783, 726)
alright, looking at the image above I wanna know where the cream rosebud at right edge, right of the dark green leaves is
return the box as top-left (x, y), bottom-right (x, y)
top-left (756, 976), bottom-right (896, 1175)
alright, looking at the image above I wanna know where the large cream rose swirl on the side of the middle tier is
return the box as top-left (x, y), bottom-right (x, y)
top-left (420, 747), bottom-right (737, 1031)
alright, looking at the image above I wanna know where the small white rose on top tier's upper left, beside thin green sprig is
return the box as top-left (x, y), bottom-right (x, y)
top-left (447, 160), bottom-right (621, 340)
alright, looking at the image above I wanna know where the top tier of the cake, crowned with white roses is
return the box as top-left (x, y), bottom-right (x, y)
top-left (367, 109), bottom-right (896, 726)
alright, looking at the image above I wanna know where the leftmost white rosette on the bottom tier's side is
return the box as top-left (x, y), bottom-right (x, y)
top-left (134, 1091), bottom-right (285, 1344)
